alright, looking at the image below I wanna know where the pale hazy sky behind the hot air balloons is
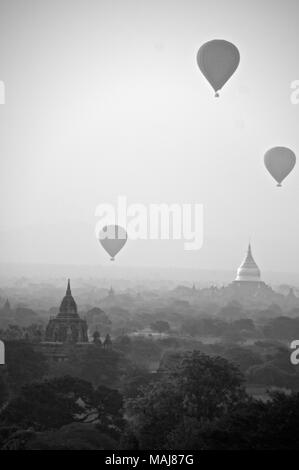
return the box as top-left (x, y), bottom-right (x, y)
top-left (0, 0), bottom-right (299, 271)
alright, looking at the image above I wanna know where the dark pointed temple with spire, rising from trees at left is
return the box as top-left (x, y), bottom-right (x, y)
top-left (45, 280), bottom-right (88, 343)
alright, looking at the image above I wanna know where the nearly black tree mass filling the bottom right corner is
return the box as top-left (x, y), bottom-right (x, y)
top-left (191, 392), bottom-right (299, 450)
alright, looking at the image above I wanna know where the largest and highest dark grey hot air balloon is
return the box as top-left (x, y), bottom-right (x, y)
top-left (197, 39), bottom-right (240, 97)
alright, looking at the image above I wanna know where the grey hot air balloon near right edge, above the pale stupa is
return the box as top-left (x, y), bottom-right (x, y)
top-left (264, 147), bottom-right (296, 186)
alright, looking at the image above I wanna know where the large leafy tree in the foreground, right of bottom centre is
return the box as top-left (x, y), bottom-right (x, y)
top-left (126, 351), bottom-right (246, 449)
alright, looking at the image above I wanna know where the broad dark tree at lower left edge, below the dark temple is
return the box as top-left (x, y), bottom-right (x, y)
top-left (0, 376), bottom-right (124, 439)
